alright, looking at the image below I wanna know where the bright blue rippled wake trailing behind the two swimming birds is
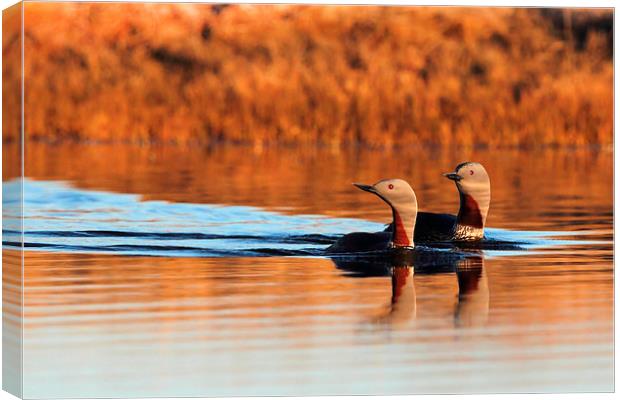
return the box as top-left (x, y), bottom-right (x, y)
top-left (3, 179), bottom-right (592, 263)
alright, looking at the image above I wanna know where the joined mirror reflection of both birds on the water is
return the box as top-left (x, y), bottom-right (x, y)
top-left (332, 253), bottom-right (489, 328)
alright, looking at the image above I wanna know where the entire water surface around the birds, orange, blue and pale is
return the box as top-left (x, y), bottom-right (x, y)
top-left (3, 144), bottom-right (613, 397)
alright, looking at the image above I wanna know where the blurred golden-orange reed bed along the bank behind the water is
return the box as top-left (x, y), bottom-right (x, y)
top-left (3, 3), bottom-right (613, 147)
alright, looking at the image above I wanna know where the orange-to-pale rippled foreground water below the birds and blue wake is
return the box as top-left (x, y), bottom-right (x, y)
top-left (9, 248), bottom-right (613, 396)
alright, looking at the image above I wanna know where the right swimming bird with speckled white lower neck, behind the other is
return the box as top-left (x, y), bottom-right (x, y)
top-left (385, 162), bottom-right (491, 242)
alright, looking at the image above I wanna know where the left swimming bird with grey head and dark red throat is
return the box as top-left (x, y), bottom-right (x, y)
top-left (326, 179), bottom-right (418, 253)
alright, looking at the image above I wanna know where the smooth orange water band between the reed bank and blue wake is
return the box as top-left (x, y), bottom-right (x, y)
top-left (5, 143), bottom-right (613, 230)
